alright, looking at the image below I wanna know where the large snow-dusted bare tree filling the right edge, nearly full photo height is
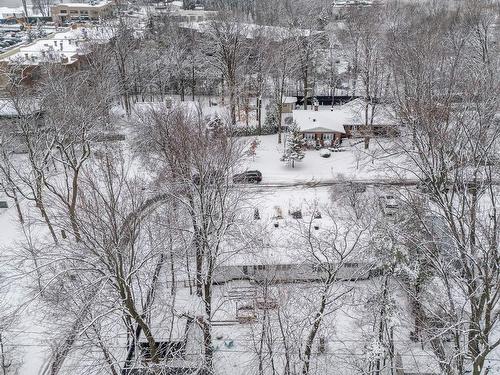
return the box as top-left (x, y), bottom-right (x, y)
top-left (382, 1), bottom-right (500, 374)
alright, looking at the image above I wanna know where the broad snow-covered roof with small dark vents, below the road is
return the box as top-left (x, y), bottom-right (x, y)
top-left (215, 188), bottom-right (373, 266)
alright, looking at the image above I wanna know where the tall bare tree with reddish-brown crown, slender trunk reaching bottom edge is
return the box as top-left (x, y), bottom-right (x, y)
top-left (135, 102), bottom-right (248, 371)
